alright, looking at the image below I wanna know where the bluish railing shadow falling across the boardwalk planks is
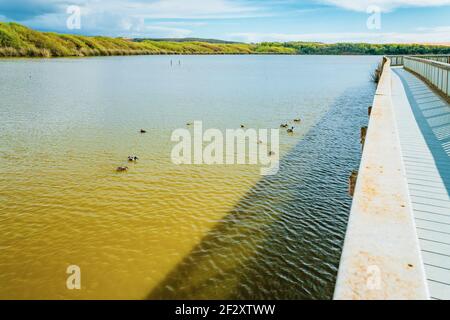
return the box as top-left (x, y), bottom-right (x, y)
top-left (395, 69), bottom-right (450, 195)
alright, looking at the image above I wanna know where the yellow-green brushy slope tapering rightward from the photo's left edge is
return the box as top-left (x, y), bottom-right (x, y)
top-left (0, 23), bottom-right (253, 57)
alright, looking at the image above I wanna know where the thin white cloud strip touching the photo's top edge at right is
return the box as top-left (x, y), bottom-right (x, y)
top-left (317, 0), bottom-right (450, 12)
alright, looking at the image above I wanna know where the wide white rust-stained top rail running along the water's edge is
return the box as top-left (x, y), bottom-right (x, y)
top-left (334, 58), bottom-right (429, 299)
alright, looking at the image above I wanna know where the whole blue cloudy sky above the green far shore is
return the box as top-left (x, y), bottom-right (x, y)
top-left (0, 0), bottom-right (450, 43)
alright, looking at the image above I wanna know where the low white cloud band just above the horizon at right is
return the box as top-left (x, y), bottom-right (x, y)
top-left (228, 27), bottom-right (450, 43)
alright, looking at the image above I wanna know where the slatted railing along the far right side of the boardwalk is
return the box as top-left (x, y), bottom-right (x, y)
top-left (403, 56), bottom-right (450, 97)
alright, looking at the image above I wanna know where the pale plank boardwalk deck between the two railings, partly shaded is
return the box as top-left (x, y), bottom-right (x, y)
top-left (392, 67), bottom-right (450, 299)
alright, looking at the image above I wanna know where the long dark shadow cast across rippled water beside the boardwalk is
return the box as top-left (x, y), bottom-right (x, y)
top-left (147, 83), bottom-right (374, 299)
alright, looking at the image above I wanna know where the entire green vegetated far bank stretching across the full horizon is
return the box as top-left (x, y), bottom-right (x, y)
top-left (0, 23), bottom-right (450, 58)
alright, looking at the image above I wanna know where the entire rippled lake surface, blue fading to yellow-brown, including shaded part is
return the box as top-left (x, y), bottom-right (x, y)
top-left (0, 56), bottom-right (380, 299)
